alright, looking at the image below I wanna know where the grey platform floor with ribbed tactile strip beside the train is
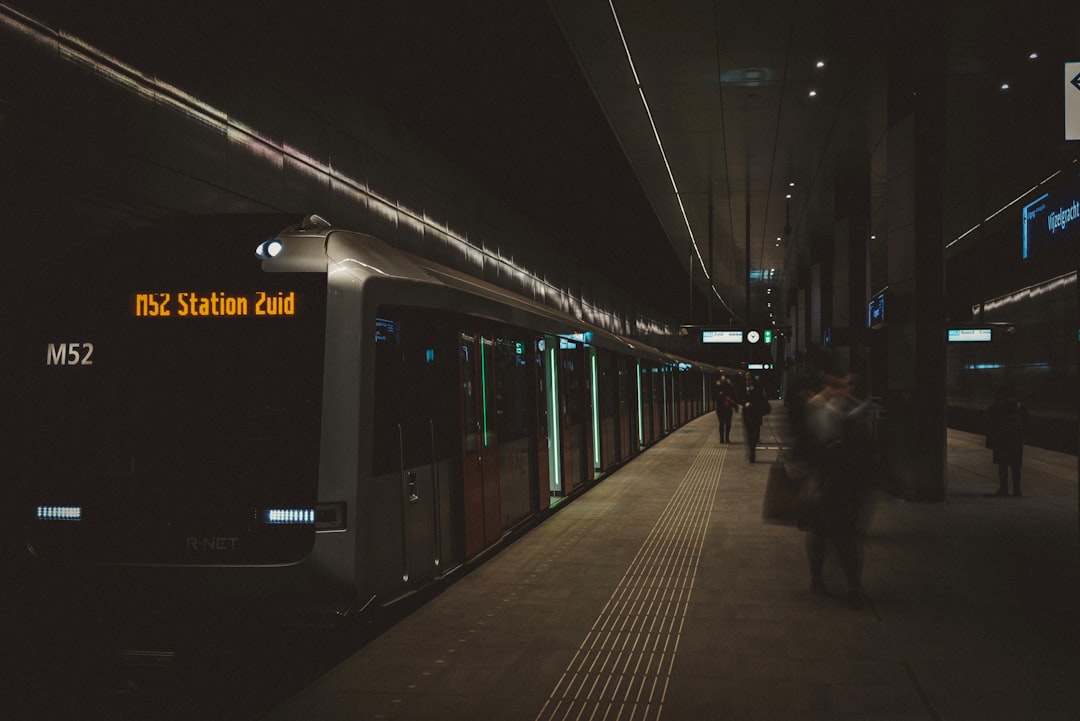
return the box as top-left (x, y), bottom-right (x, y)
top-left (266, 412), bottom-right (1080, 721)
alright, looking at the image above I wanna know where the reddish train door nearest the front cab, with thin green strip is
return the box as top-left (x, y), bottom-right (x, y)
top-left (460, 331), bottom-right (501, 557)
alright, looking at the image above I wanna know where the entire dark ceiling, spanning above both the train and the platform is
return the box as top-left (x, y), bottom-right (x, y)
top-left (13, 0), bottom-right (1080, 322)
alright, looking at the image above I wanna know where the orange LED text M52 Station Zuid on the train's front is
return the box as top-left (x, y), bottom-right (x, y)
top-left (134, 290), bottom-right (296, 318)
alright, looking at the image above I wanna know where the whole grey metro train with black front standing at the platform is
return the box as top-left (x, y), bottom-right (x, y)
top-left (6, 216), bottom-right (721, 624)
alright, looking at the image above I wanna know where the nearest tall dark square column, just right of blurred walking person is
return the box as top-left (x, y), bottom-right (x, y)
top-left (885, 21), bottom-right (946, 501)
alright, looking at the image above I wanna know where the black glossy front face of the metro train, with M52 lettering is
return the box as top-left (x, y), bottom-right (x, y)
top-left (4, 218), bottom-right (326, 564)
